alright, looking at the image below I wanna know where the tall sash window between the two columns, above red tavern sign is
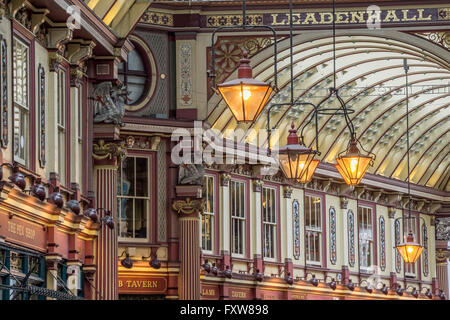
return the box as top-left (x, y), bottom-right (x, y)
top-left (117, 156), bottom-right (150, 241)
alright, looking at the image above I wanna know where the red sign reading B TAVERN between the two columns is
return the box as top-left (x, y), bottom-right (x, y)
top-left (119, 275), bottom-right (167, 294)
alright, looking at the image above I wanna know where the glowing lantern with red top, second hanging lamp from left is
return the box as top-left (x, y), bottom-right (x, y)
top-left (278, 122), bottom-right (318, 181)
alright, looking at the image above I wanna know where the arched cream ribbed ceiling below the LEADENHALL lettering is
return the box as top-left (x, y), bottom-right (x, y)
top-left (207, 30), bottom-right (450, 191)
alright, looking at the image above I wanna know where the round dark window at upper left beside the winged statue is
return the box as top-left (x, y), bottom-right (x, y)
top-left (119, 43), bottom-right (151, 105)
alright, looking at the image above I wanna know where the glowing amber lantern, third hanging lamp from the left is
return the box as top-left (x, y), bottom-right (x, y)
top-left (335, 141), bottom-right (372, 186)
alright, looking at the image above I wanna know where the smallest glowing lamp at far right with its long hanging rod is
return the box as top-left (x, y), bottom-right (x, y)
top-left (395, 59), bottom-right (425, 263)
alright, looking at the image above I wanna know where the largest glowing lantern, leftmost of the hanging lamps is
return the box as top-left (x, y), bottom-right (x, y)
top-left (217, 51), bottom-right (273, 123)
